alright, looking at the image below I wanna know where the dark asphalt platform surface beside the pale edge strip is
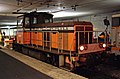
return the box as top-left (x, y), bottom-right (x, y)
top-left (0, 51), bottom-right (53, 79)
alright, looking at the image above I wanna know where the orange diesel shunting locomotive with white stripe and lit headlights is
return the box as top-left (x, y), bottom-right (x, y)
top-left (13, 12), bottom-right (106, 68)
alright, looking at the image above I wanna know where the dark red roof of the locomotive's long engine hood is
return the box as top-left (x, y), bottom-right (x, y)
top-left (31, 21), bottom-right (93, 28)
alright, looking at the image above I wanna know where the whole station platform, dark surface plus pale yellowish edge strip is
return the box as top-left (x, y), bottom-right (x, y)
top-left (0, 46), bottom-right (87, 79)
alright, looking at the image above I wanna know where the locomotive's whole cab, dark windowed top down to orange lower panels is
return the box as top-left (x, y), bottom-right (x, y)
top-left (16, 12), bottom-right (53, 45)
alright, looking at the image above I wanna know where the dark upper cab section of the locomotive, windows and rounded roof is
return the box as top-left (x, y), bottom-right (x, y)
top-left (23, 12), bottom-right (53, 27)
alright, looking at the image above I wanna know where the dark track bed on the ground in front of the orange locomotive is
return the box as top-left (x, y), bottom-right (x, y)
top-left (73, 60), bottom-right (120, 79)
